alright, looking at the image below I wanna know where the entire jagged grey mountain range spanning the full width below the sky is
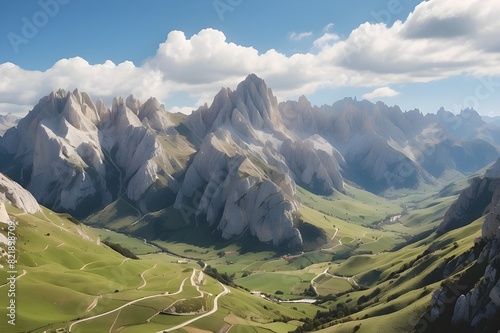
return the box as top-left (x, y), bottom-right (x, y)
top-left (0, 74), bottom-right (499, 247)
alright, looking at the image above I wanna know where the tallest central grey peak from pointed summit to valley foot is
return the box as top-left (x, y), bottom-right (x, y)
top-left (175, 75), bottom-right (312, 247)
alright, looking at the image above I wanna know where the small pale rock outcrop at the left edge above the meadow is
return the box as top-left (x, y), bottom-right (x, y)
top-left (0, 173), bottom-right (41, 214)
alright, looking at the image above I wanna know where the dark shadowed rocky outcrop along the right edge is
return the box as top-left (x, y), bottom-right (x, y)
top-left (428, 160), bottom-right (500, 333)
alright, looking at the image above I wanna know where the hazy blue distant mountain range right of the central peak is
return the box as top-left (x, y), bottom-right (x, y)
top-left (280, 96), bottom-right (500, 192)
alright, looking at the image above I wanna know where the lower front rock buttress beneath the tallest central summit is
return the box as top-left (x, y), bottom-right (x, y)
top-left (174, 130), bottom-right (301, 246)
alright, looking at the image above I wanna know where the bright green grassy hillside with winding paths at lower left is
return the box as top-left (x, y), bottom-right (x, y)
top-left (0, 202), bottom-right (324, 333)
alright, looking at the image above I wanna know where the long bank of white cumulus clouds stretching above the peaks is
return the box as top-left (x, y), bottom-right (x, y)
top-left (0, 0), bottom-right (500, 112)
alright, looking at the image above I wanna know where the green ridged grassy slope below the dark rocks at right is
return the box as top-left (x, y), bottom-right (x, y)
top-left (308, 218), bottom-right (484, 333)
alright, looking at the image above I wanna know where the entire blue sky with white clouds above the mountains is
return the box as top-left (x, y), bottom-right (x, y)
top-left (0, 0), bottom-right (500, 115)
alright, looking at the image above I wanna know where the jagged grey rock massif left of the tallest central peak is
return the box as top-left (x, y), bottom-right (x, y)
top-left (0, 90), bottom-right (193, 217)
